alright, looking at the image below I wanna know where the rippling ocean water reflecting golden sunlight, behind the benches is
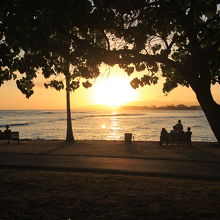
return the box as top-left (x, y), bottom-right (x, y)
top-left (0, 110), bottom-right (216, 142)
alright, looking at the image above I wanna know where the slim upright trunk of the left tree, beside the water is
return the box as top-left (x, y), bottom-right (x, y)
top-left (66, 73), bottom-right (74, 143)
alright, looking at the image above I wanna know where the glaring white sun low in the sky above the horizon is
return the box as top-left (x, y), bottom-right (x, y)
top-left (93, 77), bottom-right (137, 107)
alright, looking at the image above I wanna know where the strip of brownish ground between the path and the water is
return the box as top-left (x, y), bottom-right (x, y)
top-left (0, 140), bottom-right (220, 162)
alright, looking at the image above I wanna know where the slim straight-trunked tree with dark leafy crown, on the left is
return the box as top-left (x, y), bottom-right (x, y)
top-left (0, 0), bottom-right (104, 142)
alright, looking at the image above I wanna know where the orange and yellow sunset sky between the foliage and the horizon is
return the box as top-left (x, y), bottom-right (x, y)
top-left (0, 66), bottom-right (220, 110)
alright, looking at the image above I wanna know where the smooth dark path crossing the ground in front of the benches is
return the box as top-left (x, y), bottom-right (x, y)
top-left (0, 153), bottom-right (220, 181)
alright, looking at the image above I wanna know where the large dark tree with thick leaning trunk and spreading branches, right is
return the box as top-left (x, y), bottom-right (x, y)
top-left (93, 0), bottom-right (220, 142)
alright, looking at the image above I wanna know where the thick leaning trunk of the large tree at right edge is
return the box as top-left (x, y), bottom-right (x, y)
top-left (194, 83), bottom-right (220, 143)
